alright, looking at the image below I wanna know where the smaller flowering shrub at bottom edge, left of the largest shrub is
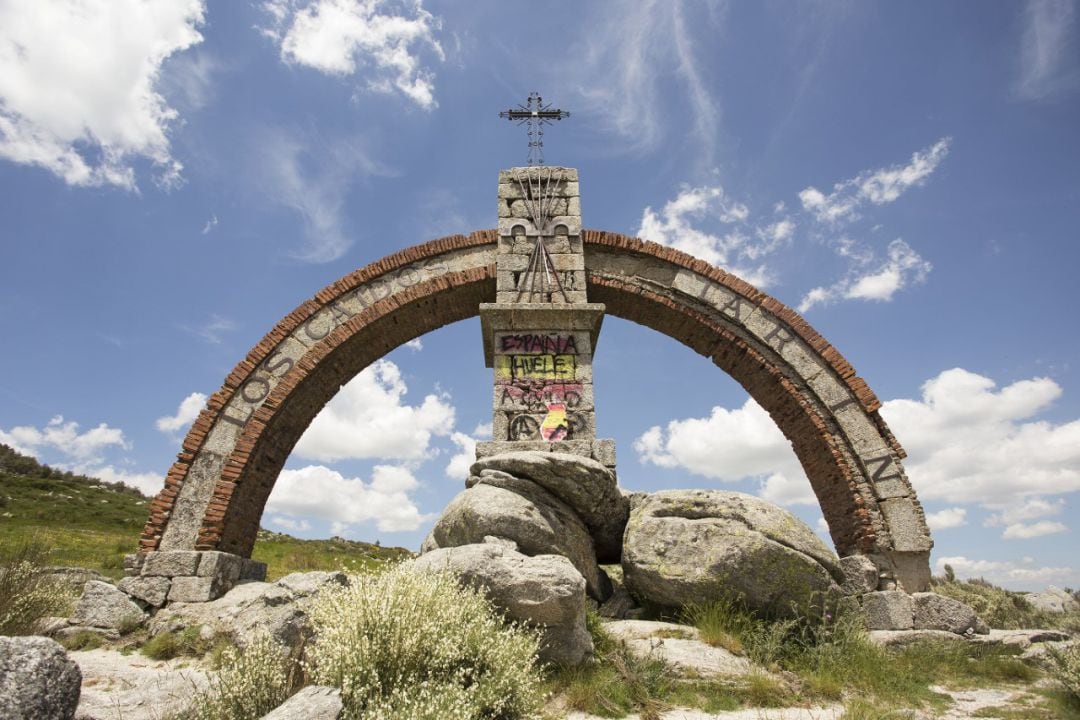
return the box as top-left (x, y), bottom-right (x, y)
top-left (183, 635), bottom-right (297, 720)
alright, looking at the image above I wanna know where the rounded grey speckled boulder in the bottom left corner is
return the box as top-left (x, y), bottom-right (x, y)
top-left (0, 637), bottom-right (82, 720)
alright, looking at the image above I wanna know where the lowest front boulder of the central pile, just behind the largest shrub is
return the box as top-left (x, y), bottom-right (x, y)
top-left (414, 541), bottom-right (593, 665)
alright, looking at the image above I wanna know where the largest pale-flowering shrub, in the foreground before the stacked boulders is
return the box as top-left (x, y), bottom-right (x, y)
top-left (308, 565), bottom-right (542, 720)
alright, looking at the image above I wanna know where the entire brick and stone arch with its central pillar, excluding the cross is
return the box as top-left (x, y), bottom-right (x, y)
top-left (138, 166), bottom-right (932, 600)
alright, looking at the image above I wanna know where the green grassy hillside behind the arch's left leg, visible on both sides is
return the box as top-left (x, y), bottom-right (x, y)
top-left (0, 444), bottom-right (409, 579)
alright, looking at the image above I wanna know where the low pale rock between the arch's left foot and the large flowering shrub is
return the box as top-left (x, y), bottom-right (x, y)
top-left (150, 572), bottom-right (348, 648)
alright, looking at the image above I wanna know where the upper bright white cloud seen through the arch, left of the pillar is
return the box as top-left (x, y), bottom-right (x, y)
top-left (294, 359), bottom-right (454, 462)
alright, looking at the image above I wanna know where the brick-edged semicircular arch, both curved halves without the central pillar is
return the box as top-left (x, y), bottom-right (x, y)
top-left (140, 230), bottom-right (931, 592)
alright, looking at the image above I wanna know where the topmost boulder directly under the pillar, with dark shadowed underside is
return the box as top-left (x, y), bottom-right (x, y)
top-left (467, 450), bottom-right (630, 562)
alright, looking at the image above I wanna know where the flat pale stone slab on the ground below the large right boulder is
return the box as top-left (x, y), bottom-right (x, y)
top-left (604, 620), bottom-right (754, 677)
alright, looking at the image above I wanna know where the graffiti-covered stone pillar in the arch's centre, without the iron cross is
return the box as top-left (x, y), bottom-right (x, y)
top-left (476, 166), bottom-right (615, 467)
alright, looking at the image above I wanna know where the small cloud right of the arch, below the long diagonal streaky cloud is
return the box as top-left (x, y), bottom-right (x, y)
top-left (798, 239), bottom-right (933, 313)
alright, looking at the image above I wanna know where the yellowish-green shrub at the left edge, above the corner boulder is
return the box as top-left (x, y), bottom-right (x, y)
top-left (0, 541), bottom-right (72, 635)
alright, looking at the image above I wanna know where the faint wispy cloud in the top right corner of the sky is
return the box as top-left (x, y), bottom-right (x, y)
top-left (1013, 0), bottom-right (1080, 100)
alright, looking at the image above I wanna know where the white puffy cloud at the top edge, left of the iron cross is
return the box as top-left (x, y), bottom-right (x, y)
top-left (264, 0), bottom-right (445, 110)
